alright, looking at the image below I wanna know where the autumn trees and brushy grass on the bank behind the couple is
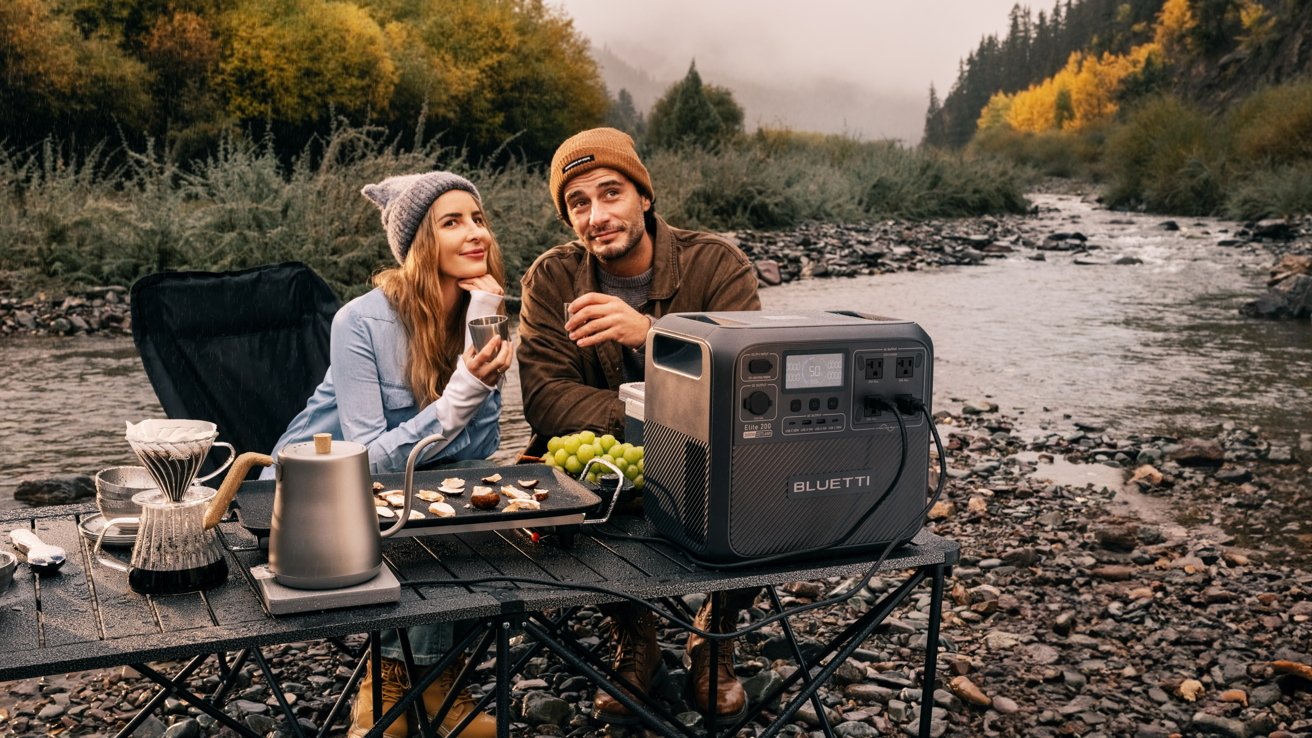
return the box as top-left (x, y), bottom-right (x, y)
top-left (0, 0), bottom-right (1027, 298)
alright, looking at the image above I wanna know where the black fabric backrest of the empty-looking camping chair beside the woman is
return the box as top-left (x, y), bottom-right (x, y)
top-left (131, 261), bottom-right (340, 467)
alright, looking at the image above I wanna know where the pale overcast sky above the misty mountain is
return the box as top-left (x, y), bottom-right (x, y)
top-left (548, 0), bottom-right (1028, 137)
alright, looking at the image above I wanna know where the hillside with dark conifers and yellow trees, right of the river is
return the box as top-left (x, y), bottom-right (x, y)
top-left (925, 0), bottom-right (1312, 219)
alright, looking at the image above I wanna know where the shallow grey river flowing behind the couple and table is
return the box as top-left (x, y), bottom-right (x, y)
top-left (0, 194), bottom-right (1312, 522)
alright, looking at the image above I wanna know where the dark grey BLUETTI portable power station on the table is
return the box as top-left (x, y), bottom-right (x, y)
top-left (643, 311), bottom-right (934, 562)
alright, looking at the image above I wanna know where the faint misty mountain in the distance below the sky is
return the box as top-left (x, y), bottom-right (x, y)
top-left (592, 46), bottom-right (925, 143)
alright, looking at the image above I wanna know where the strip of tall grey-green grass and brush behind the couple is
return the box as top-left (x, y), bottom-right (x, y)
top-left (0, 125), bottom-right (1026, 302)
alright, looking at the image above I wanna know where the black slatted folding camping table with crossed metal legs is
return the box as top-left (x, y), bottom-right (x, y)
top-left (0, 494), bottom-right (959, 737)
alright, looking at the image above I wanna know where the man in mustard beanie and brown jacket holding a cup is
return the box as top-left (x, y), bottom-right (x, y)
top-left (520, 129), bottom-right (761, 724)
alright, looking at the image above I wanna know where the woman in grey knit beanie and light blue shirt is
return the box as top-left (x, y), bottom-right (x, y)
top-left (268, 172), bottom-right (513, 738)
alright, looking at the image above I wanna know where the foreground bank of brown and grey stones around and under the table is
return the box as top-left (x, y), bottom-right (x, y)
top-left (0, 401), bottom-right (1312, 738)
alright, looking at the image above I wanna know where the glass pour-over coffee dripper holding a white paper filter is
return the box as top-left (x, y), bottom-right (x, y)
top-left (127, 419), bottom-right (236, 502)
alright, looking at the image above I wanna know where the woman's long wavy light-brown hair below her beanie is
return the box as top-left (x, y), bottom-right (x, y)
top-left (374, 200), bottom-right (505, 407)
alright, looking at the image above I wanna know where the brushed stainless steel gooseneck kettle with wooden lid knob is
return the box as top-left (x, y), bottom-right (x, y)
top-left (215, 433), bottom-right (446, 590)
